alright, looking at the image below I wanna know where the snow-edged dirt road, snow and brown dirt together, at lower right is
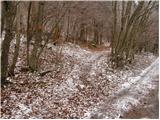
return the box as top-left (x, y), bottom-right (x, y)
top-left (85, 58), bottom-right (159, 119)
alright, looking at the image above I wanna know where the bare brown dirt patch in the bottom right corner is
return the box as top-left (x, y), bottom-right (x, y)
top-left (122, 86), bottom-right (159, 119)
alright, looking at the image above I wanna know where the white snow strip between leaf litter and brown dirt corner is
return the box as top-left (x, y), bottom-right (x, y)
top-left (85, 59), bottom-right (159, 118)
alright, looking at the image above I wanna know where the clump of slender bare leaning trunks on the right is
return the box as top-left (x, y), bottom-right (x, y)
top-left (112, 1), bottom-right (154, 67)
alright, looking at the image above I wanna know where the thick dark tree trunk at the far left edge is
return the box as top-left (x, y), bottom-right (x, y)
top-left (1, 1), bottom-right (16, 85)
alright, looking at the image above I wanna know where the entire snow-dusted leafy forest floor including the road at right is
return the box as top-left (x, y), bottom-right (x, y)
top-left (1, 43), bottom-right (159, 119)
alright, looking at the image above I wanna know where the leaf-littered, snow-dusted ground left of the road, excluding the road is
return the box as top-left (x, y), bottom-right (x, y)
top-left (1, 43), bottom-right (156, 118)
